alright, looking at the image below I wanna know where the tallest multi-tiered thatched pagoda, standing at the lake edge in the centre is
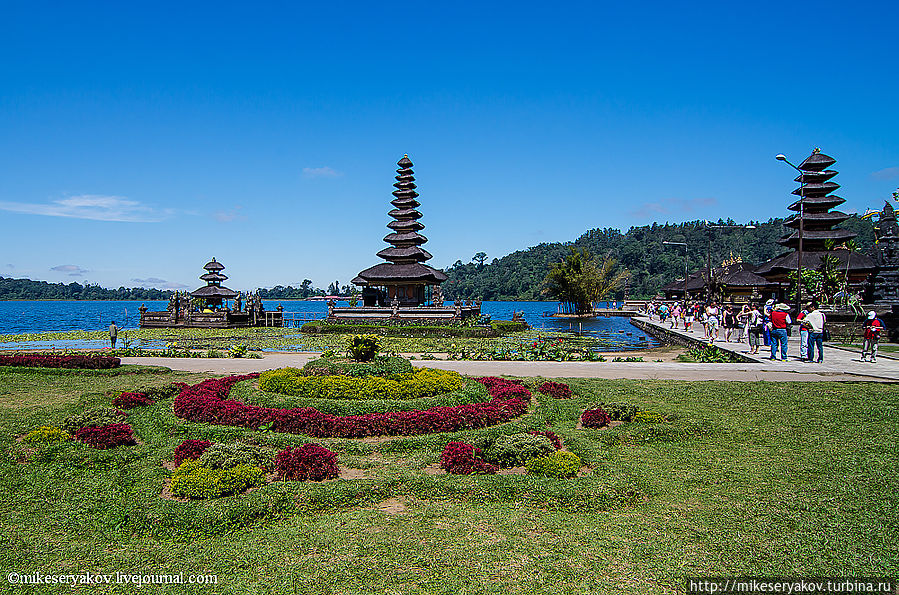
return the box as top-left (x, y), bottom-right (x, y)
top-left (353, 155), bottom-right (446, 306)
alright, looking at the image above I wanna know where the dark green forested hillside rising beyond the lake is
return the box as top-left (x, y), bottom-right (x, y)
top-left (443, 215), bottom-right (874, 300)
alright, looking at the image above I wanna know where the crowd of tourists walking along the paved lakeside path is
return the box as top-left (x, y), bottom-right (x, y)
top-left (643, 299), bottom-right (884, 363)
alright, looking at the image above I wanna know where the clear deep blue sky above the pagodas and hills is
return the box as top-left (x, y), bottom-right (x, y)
top-left (0, 2), bottom-right (899, 289)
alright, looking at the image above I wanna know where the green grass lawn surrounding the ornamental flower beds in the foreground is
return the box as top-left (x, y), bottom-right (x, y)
top-left (0, 367), bottom-right (899, 595)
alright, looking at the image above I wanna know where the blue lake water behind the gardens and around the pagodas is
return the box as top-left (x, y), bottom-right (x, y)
top-left (0, 300), bottom-right (658, 349)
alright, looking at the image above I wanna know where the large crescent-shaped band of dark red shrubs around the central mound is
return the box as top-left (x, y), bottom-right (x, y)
top-left (173, 374), bottom-right (531, 438)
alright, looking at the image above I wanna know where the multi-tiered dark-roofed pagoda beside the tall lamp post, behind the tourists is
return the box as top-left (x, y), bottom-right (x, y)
top-left (756, 149), bottom-right (874, 289)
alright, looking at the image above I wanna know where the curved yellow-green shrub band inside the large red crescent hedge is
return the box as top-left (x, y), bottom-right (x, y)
top-left (259, 368), bottom-right (466, 399)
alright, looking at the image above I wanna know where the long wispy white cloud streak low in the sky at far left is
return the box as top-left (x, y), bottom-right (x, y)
top-left (0, 194), bottom-right (174, 223)
